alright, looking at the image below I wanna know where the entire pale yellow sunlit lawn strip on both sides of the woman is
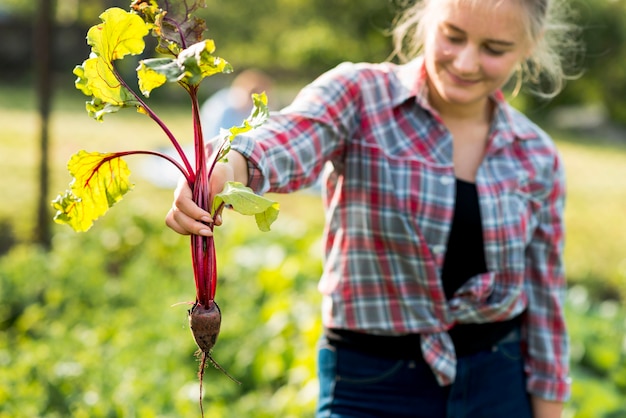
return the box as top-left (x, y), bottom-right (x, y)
top-left (0, 81), bottom-right (626, 297)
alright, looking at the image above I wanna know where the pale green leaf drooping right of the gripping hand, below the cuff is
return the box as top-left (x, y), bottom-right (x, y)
top-left (213, 182), bottom-right (280, 232)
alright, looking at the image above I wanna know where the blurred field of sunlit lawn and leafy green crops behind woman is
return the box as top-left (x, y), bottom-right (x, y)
top-left (0, 86), bottom-right (626, 418)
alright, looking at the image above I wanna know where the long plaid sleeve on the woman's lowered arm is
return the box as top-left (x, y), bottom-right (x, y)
top-left (525, 150), bottom-right (571, 402)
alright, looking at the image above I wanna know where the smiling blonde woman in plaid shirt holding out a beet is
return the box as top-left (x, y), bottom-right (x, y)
top-left (166, 0), bottom-right (569, 418)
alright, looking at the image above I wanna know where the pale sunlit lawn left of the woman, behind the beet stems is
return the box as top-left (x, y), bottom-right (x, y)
top-left (0, 94), bottom-right (177, 236)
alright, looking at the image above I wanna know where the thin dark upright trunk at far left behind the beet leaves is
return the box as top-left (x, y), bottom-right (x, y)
top-left (33, 0), bottom-right (54, 249)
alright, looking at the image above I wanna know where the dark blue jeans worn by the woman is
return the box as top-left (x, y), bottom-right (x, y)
top-left (316, 339), bottom-right (532, 418)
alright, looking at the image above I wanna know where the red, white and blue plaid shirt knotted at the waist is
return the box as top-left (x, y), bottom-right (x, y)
top-left (232, 58), bottom-right (570, 401)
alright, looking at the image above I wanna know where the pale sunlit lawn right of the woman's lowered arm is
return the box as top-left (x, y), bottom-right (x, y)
top-left (558, 136), bottom-right (626, 299)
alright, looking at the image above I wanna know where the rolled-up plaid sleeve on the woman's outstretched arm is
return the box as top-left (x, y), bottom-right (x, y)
top-left (231, 63), bottom-right (361, 193)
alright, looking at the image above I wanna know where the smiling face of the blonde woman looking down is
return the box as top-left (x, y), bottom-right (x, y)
top-left (424, 0), bottom-right (531, 111)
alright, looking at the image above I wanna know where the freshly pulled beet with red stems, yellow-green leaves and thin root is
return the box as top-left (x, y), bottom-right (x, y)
top-left (52, 0), bottom-right (278, 408)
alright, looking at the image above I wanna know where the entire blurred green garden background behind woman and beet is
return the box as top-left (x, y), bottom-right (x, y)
top-left (0, 0), bottom-right (626, 418)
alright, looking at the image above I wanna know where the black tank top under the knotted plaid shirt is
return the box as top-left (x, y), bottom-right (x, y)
top-left (442, 179), bottom-right (521, 355)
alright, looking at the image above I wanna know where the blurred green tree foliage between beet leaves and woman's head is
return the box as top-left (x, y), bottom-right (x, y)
top-left (197, 0), bottom-right (397, 80)
